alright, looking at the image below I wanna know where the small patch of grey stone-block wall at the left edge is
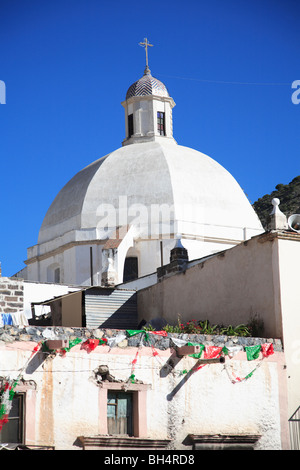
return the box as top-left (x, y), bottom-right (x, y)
top-left (0, 277), bottom-right (24, 313)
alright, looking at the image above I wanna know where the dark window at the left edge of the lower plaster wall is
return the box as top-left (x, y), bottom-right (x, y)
top-left (0, 393), bottom-right (24, 444)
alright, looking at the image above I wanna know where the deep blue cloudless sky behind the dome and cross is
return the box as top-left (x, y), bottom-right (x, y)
top-left (0, 0), bottom-right (300, 276)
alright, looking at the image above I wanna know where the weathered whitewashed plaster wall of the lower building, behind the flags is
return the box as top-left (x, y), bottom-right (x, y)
top-left (0, 327), bottom-right (288, 450)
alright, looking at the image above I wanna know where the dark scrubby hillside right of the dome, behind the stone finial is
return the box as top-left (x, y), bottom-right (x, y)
top-left (253, 176), bottom-right (300, 229)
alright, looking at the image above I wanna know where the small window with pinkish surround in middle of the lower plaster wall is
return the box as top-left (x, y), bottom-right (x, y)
top-left (107, 390), bottom-right (133, 436)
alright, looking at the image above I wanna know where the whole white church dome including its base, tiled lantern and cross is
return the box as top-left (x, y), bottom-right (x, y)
top-left (26, 52), bottom-right (263, 285)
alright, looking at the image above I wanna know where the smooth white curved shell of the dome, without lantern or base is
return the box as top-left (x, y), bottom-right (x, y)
top-left (38, 139), bottom-right (263, 244)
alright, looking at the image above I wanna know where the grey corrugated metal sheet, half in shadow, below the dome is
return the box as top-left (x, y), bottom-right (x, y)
top-left (84, 289), bottom-right (137, 329)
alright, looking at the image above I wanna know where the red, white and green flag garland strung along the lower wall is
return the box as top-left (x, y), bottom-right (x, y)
top-left (0, 330), bottom-right (274, 431)
